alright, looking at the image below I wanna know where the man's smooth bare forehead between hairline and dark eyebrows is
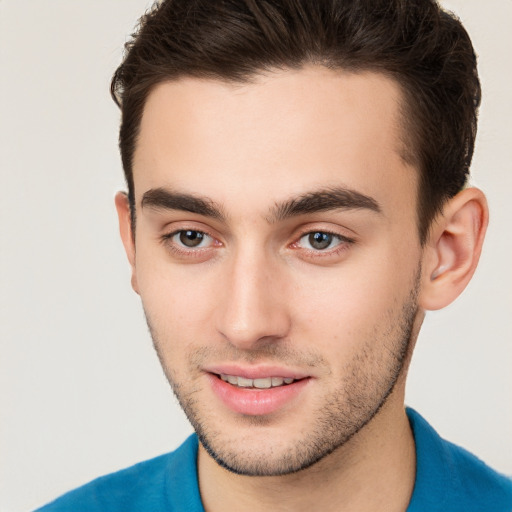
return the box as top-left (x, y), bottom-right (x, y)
top-left (133, 66), bottom-right (416, 220)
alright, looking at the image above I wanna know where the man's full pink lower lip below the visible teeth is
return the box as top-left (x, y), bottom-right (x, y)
top-left (208, 373), bottom-right (310, 416)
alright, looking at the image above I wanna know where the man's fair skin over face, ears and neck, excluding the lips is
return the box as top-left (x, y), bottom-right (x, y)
top-left (116, 66), bottom-right (487, 511)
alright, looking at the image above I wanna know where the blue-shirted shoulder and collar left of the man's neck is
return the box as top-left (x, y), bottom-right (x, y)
top-left (36, 436), bottom-right (201, 512)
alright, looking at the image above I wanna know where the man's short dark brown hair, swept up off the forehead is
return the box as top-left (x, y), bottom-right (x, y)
top-left (111, 0), bottom-right (481, 243)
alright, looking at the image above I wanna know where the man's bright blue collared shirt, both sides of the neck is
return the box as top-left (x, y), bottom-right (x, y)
top-left (36, 409), bottom-right (512, 512)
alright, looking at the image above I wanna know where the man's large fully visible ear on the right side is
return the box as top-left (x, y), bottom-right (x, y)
top-left (419, 188), bottom-right (489, 310)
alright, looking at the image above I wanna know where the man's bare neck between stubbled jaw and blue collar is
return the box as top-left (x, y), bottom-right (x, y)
top-left (198, 392), bottom-right (416, 512)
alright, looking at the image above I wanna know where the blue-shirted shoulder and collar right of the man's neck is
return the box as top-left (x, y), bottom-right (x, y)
top-left (407, 409), bottom-right (512, 512)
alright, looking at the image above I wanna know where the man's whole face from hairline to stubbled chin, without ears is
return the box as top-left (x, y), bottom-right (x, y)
top-left (123, 67), bottom-right (421, 475)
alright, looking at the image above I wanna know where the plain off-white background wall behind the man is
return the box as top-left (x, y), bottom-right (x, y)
top-left (0, 0), bottom-right (512, 512)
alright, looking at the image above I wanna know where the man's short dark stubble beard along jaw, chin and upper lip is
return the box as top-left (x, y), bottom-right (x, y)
top-left (146, 270), bottom-right (420, 476)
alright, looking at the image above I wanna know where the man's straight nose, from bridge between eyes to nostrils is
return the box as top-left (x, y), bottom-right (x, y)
top-left (213, 247), bottom-right (290, 350)
